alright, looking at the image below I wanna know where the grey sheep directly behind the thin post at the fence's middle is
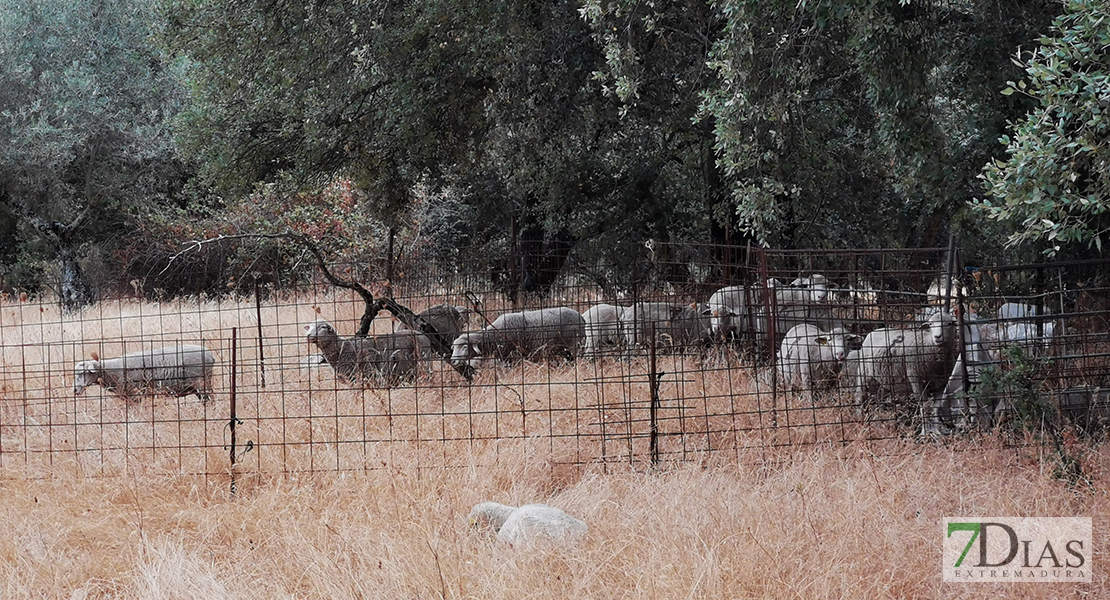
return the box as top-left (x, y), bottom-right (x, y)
top-left (620, 302), bottom-right (712, 349)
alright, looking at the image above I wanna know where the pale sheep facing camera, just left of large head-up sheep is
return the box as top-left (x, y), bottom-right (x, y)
top-left (778, 323), bottom-right (859, 401)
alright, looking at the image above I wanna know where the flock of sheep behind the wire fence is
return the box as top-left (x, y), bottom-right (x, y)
top-left (73, 274), bottom-right (1055, 431)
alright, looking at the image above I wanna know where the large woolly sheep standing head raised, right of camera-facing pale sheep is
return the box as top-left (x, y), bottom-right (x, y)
top-left (856, 312), bottom-right (960, 433)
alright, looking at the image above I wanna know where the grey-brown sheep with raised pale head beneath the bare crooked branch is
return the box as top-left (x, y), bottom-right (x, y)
top-left (304, 321), bottom-right (432, 385)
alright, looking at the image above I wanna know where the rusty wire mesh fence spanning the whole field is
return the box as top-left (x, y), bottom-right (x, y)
top-left (0, 240), bottom-right (1110, 477)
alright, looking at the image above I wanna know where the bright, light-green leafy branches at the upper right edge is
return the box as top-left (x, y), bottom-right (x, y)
top-left (977, 0), bottom-right (1110, 254)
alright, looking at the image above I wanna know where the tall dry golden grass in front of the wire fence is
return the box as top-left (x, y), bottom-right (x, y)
top-left (0, 438), bottom-right (1110, 600)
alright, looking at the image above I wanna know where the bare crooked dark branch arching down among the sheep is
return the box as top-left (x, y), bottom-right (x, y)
top-left (162, 232), bottom-right (474, 382)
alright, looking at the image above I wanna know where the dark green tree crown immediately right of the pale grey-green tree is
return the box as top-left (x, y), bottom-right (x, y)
top-left (165, 1), bottom-right (500, 218)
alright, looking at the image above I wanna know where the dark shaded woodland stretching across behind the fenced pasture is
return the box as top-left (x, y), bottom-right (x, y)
top-left (0, 0), bottom-right (1110, 308)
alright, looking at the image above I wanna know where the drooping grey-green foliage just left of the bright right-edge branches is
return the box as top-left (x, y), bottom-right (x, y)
top-left (703, 0), bottom-right (1053, 247)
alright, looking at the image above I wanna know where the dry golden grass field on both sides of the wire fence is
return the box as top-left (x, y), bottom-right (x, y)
top-left (0, 295), bottom-right (1110, 599)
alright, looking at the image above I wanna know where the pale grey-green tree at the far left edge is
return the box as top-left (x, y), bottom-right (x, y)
top-left (0, 0), bottom-right (184, 308)
